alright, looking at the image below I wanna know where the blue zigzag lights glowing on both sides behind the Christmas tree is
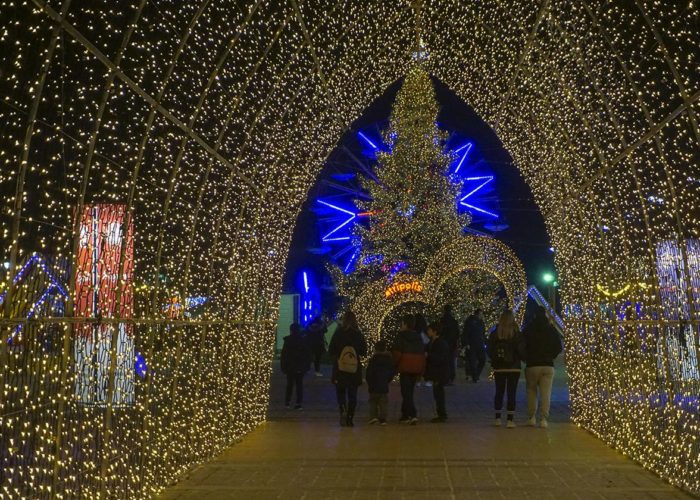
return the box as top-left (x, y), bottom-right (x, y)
top-left (314, 124), bottom-right (508, 274)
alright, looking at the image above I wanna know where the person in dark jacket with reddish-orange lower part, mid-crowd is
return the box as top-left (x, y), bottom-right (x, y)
top-left (392, 314), bottom-right (425, 425)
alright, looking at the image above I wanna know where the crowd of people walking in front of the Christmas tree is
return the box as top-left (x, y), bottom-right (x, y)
top-left (281, 306), bottom-right (562, 428)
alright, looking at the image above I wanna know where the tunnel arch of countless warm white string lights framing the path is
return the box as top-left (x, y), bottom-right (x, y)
top-left (0, 0), bottom-right (700, 497)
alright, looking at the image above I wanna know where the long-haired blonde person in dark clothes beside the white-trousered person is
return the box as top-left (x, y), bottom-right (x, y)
top-left (488, 310), bottom-right (525, 428)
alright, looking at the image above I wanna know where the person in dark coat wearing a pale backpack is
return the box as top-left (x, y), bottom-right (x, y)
top-left (328, 311), bottom-right (367, 427)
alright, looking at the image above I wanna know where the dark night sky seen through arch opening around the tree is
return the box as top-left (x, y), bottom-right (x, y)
top-left (283, 79), bottom-right (554, 309)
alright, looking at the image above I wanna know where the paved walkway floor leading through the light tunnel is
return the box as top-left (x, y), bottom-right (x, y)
top-left (163, 360), bottom-right (688, 500)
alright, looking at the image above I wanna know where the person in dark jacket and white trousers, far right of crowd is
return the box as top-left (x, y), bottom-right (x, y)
top-left (523, 306), bottom-right (562, 429)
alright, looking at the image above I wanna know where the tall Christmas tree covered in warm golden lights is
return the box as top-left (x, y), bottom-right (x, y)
top-left (354, 65), bottom-right (470, 279)
